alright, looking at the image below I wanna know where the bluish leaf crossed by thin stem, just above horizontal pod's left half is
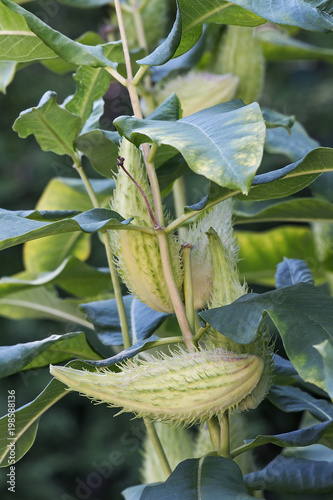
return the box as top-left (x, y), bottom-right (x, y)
top-left (81, 295), bottom-right (169, 346)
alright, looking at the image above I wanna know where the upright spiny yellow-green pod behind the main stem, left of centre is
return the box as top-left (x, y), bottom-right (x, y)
top-left (109, 138), bottom-right (183, 313)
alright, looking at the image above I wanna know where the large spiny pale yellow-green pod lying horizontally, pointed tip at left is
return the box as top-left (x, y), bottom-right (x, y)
top-left (50, 349), bottom-right (264, 425)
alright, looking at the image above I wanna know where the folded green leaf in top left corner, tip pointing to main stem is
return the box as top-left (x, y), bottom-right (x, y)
top-left (0, 0), bottom-right (113, 67)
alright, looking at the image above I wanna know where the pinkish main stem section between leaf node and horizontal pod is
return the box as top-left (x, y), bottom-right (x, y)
top-left (156, 229), bottom-right (194, 350)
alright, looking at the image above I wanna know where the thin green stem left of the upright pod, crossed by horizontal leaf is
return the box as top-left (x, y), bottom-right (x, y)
top-left (74, 160), bottom-right (132, 349)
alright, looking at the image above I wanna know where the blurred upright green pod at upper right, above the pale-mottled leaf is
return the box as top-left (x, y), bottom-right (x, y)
top-left (214, 26), bottom-right (265, 104)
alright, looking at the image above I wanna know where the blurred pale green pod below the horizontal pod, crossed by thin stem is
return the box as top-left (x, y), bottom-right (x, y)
top-left (141, 422), bottom-right (194, 484)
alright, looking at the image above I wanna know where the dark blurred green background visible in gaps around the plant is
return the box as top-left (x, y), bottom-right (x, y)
top-left (0, 2), bottom-right (333, 500)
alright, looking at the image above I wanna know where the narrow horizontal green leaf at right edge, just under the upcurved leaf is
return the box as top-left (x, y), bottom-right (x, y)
top-left (233, 198), bottom-right (333, 224)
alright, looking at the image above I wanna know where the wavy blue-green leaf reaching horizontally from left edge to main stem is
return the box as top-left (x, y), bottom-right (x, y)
top-left (0, 208), bottom-right (130, 250)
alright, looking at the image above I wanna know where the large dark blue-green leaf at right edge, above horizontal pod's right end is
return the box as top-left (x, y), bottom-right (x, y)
top-left (200, 283), bottom-right (333, 391)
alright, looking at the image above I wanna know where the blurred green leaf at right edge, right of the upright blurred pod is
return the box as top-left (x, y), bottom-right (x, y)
top-left (256, 27), bottom-right (333, 63)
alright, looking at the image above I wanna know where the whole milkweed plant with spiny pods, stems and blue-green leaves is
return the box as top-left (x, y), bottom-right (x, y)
top-left (0, 0), bottom-right (333, 500)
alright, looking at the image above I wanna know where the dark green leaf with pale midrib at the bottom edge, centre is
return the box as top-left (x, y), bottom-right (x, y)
top-left (140, 456), bottom-right (253, 500)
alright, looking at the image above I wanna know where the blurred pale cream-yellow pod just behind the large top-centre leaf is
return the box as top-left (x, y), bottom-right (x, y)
top-left (144, 71), bottom-right (238, 117)
